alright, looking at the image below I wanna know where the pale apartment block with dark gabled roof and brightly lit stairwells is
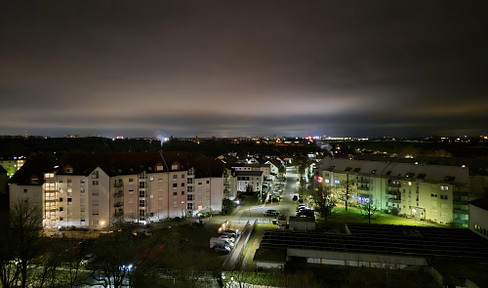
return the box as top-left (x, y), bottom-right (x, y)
top-left (10, 152), bottom-right (223, 228)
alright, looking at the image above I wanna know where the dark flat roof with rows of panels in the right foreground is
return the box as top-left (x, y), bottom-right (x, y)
top-left (260, 224), bottom-right (488, 262)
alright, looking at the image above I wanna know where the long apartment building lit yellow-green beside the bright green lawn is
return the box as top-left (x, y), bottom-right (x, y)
top-left (316, 157), bottom-right (483, 227)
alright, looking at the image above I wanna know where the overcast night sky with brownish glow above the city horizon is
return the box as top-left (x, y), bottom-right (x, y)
top-left (0, 0), bottom-right (488, 137)
